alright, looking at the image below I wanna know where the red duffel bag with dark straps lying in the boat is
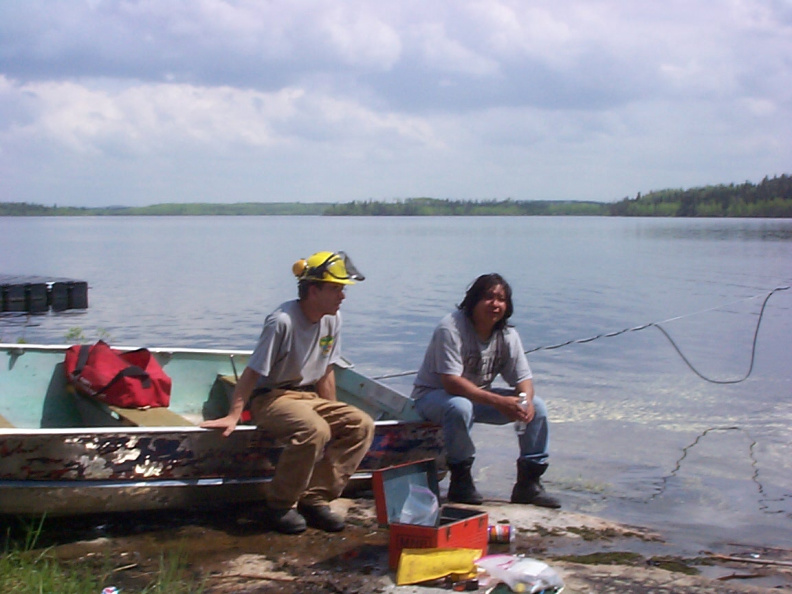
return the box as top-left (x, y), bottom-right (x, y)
top-left (64, 340), bottom-right (171, 408)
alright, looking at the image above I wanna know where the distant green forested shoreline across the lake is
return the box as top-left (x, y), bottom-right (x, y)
top-left (0, 174), bottom-right (792, 218)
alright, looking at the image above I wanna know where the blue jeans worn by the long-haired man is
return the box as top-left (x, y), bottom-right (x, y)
top-left (415, 388), bottom-right (550, 464)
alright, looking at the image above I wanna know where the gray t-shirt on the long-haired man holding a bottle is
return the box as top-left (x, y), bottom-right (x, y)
top-left (412, 310), bottom-right (532, 400)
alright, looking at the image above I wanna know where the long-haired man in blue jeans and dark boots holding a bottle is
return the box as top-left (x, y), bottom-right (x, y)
top-left (412, 273), bottom-right (560, 508)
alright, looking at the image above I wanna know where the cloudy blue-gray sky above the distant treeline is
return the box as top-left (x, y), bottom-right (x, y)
top-left (0, 0), bottom-right (792, 206)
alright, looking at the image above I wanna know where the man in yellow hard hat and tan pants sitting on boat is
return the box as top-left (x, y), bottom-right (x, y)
top-left (202, 252), bottom-right (374, 534)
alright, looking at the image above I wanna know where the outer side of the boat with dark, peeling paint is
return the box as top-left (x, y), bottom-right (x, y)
top-left (0, 421), bottom-right (442, 515)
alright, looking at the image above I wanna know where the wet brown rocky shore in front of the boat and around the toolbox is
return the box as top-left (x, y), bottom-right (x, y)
top-left (24, 497), bottom-right (792, 594)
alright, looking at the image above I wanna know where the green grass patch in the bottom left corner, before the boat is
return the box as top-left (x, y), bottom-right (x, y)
top-left (0, 517), bottom-right (204, 594)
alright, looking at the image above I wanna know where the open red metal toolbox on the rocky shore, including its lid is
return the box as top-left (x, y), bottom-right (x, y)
top-left (372, 460), bottom-right (489, 570)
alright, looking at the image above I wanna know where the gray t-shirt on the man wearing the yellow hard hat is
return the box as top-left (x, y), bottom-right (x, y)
top-left (248, 300), bottom-right (341, 388)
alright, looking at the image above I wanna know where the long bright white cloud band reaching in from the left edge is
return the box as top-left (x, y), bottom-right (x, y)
top-left (0, 78), bottom-right (437, 154)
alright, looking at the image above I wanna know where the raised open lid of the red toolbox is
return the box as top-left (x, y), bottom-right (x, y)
top-left (371, 459), bottom-right (440, 526)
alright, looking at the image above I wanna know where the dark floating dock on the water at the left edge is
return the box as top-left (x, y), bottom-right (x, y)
top-left (0, 274), bottom-right (88, 313)
